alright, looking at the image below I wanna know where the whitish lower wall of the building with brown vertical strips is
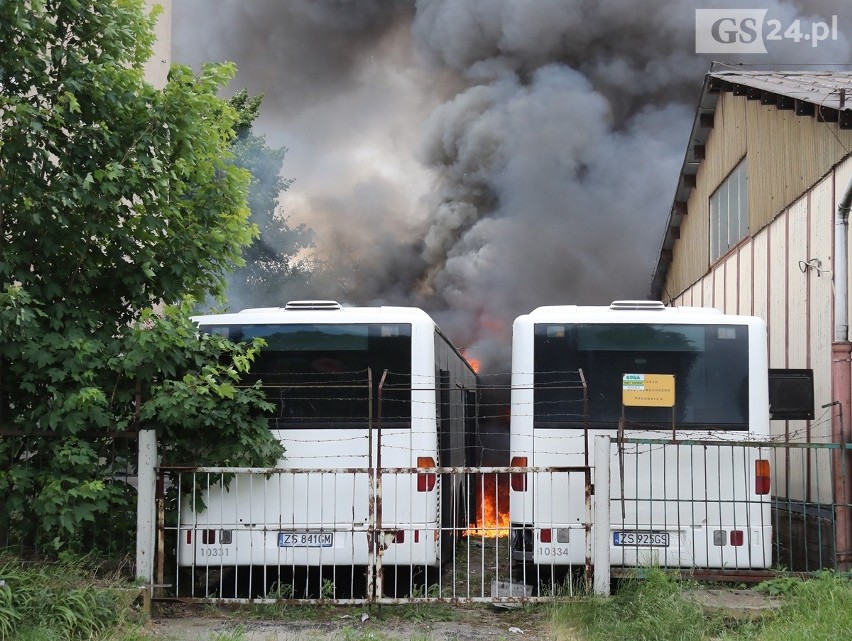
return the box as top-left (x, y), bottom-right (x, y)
top-left (674, 165), bottom-right (852, 502)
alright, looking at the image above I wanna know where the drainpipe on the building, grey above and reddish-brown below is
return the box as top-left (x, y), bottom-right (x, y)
top-left (831, 180), bottom-right (852, 572)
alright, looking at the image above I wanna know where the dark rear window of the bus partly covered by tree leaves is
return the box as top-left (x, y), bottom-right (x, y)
top-left (201, 323), bottom-right (411, 429)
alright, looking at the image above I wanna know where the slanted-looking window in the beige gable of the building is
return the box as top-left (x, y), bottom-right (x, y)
top-left (710, 158), bottom-right (748, 263)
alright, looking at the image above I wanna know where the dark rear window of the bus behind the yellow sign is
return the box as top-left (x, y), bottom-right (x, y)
top-left (534, 323), bottom-right (748, 430)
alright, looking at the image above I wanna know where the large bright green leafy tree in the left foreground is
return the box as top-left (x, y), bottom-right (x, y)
top-left (0, 0), bottom-right (281, 549)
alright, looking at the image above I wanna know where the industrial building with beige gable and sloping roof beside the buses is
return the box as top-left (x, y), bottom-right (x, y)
top-left (649, 64), bottom-right (852, 569)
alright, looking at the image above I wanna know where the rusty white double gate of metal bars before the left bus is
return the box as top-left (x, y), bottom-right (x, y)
top-left (153, 467), bottom-right (592, 606)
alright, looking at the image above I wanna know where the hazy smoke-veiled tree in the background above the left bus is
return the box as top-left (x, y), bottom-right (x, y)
top-left (230, 90), bottom-right (313, 307)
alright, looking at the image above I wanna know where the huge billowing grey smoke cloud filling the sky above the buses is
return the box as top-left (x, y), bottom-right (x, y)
top-left (173, 0), bottom-right (852, 372)
